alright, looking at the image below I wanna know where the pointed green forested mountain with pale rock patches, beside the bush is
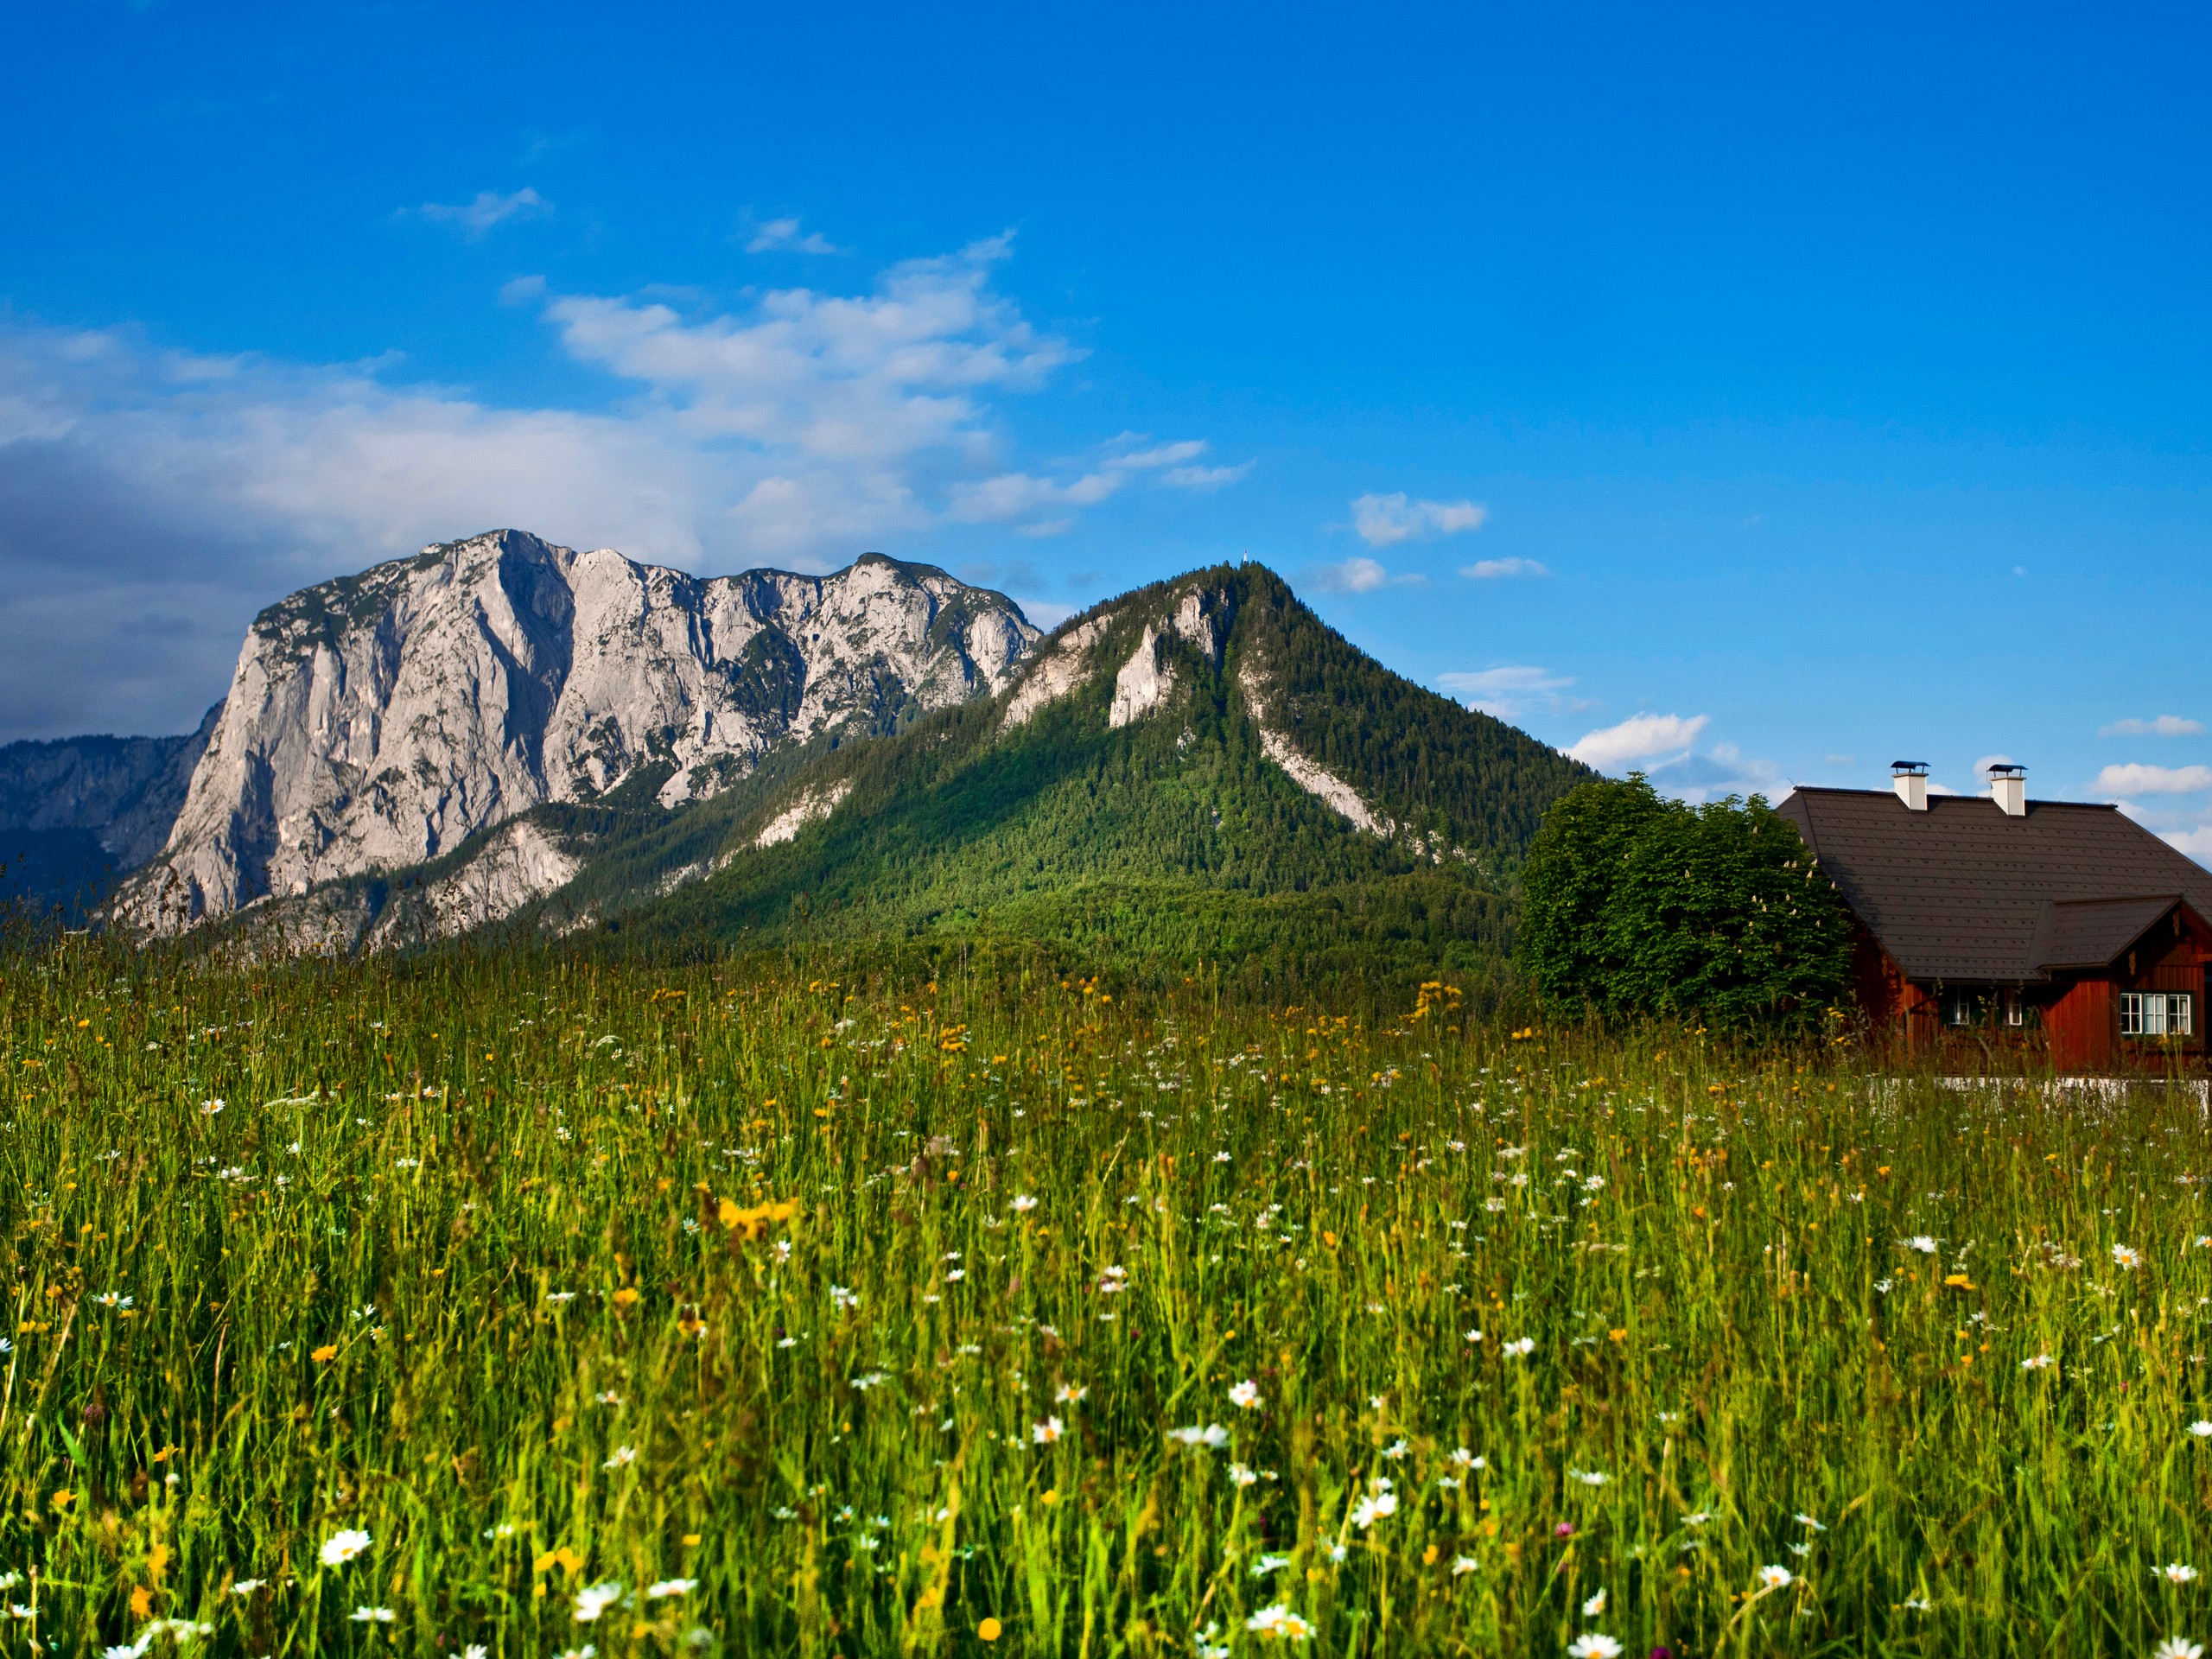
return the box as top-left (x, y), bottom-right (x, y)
top-left (224, 564), bottom-right (1592, 971)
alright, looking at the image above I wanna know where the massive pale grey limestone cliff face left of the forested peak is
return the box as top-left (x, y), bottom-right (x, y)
top-left (115, 531), bottom-right (1038, 933)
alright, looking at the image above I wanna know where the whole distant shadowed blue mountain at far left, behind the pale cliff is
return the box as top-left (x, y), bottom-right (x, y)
top-left (0, 703), bottom-right (224, 925)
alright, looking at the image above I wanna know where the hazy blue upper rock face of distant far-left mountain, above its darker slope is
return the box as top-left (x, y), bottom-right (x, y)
top-left (0, 703), bottom-right (224, 869)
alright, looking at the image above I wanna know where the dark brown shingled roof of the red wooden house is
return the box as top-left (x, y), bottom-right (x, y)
top-left (1777, 790), bottom-right (2212, 984)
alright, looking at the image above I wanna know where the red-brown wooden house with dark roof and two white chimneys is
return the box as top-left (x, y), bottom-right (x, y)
top-left (1777, 761), bottom-right (2212, 1073)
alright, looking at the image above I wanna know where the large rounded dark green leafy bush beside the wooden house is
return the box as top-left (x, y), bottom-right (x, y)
top-left (1517, 774), bottom-right (1849, 1027)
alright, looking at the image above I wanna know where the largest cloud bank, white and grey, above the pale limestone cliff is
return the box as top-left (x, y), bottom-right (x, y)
top-left (0, 238), bottom-right (1204, 741)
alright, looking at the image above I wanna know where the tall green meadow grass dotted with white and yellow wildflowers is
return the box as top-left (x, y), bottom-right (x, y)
top-left (0, 940), bottom-right (2212, 1656)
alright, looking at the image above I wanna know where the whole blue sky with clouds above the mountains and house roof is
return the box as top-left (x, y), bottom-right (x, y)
top-left (0, 0), bottom-right (2212, 856)
